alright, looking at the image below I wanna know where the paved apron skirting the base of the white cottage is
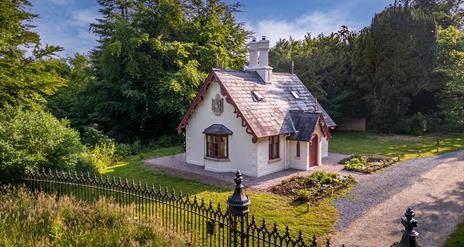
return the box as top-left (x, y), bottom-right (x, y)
top-left (145, 153), bottom-right (354, 191)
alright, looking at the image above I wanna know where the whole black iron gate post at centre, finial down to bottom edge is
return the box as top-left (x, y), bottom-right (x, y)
top-left (227, 171), bottom-right (250, 246)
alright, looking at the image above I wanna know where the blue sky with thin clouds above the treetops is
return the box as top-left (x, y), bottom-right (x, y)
top-left (31, 0), bottom-right (393, 56)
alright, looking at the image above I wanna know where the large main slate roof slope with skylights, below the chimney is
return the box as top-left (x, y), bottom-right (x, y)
top-left (213, 69), bottom-right (336, 137)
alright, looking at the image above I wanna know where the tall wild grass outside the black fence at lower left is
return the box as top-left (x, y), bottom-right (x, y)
top-left (0, 188), bottom-right (188, 246)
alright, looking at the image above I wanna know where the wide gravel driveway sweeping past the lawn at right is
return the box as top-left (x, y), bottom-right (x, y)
top-left (334, 151), bottom-right (464, 247)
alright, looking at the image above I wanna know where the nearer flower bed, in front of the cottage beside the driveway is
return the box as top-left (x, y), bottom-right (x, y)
top-left (271, 171), bottom-right (355, 203)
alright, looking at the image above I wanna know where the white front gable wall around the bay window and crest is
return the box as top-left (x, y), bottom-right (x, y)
top-left (185, 82), bottom-right (258, 176)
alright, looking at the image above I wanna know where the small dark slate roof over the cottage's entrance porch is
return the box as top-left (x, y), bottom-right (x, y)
top-left (287, 111), bottom-right (321, 141)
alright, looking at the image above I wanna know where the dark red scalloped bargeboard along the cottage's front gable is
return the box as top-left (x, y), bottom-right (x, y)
top-left (176, 70), bottom-right (258, 143)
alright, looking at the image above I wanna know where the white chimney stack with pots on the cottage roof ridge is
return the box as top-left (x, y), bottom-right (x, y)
top-left (246, 36), bottom-right (272, 83)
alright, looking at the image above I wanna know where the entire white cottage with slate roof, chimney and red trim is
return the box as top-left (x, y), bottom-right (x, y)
top-left (177, 38), bottom-right (335, 177)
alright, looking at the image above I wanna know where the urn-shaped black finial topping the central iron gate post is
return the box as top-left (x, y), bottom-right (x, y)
top-left (227, 171), bottom-right (250, 216)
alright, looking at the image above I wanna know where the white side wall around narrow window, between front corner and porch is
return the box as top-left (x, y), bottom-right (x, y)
top-left (257, 135), bottom-right (287, 177)
